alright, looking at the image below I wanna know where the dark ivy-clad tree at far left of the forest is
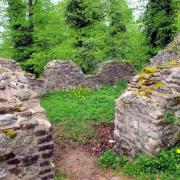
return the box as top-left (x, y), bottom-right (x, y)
top-left (7, 0), bottom-right (33, 61)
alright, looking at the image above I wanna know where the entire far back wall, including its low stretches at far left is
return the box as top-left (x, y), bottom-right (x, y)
top-left (0, 59), bottom-right (135, 95)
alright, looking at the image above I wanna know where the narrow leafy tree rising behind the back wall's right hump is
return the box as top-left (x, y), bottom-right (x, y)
top-left (107, 0), bottom-right (131, 59)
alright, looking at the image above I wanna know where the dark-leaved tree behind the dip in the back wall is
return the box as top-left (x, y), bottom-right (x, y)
top-left (66, 0), bottom-right (104, 72)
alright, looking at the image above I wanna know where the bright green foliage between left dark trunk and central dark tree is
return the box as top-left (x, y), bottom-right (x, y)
top-left (22, 0), bottom-right (75, 76)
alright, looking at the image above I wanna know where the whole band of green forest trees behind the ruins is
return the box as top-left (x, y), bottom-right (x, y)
top-left (0, 0), bottom-right (180, 76)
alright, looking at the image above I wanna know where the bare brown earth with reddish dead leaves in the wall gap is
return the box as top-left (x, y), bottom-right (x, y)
top-left (54, 125), bottom-right (132, 180)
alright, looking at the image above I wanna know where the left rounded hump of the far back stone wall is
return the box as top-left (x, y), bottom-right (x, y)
top-left (44, 60), bottom-right (86, 91)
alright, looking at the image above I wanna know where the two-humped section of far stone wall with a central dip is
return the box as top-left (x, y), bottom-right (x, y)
top-left (44, 60), bottom-right (134, 91)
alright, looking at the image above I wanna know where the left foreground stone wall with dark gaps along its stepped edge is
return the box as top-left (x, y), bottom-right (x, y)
top-left (0, 61), bottom-right (54, 180)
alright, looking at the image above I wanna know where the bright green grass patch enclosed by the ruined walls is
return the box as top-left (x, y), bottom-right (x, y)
top-left (41, 81), bottom-right (127, 143)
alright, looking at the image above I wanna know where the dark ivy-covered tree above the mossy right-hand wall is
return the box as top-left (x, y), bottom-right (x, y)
top-left (144, 0), bottom-right (176, 54)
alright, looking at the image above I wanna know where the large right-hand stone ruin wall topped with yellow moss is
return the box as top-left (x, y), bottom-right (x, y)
top-left (114, 41), bottom-right (180, 158)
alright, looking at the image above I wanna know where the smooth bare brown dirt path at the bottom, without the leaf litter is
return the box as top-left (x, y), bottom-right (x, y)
top-left (56, 146), bottom-right (130, 180)
